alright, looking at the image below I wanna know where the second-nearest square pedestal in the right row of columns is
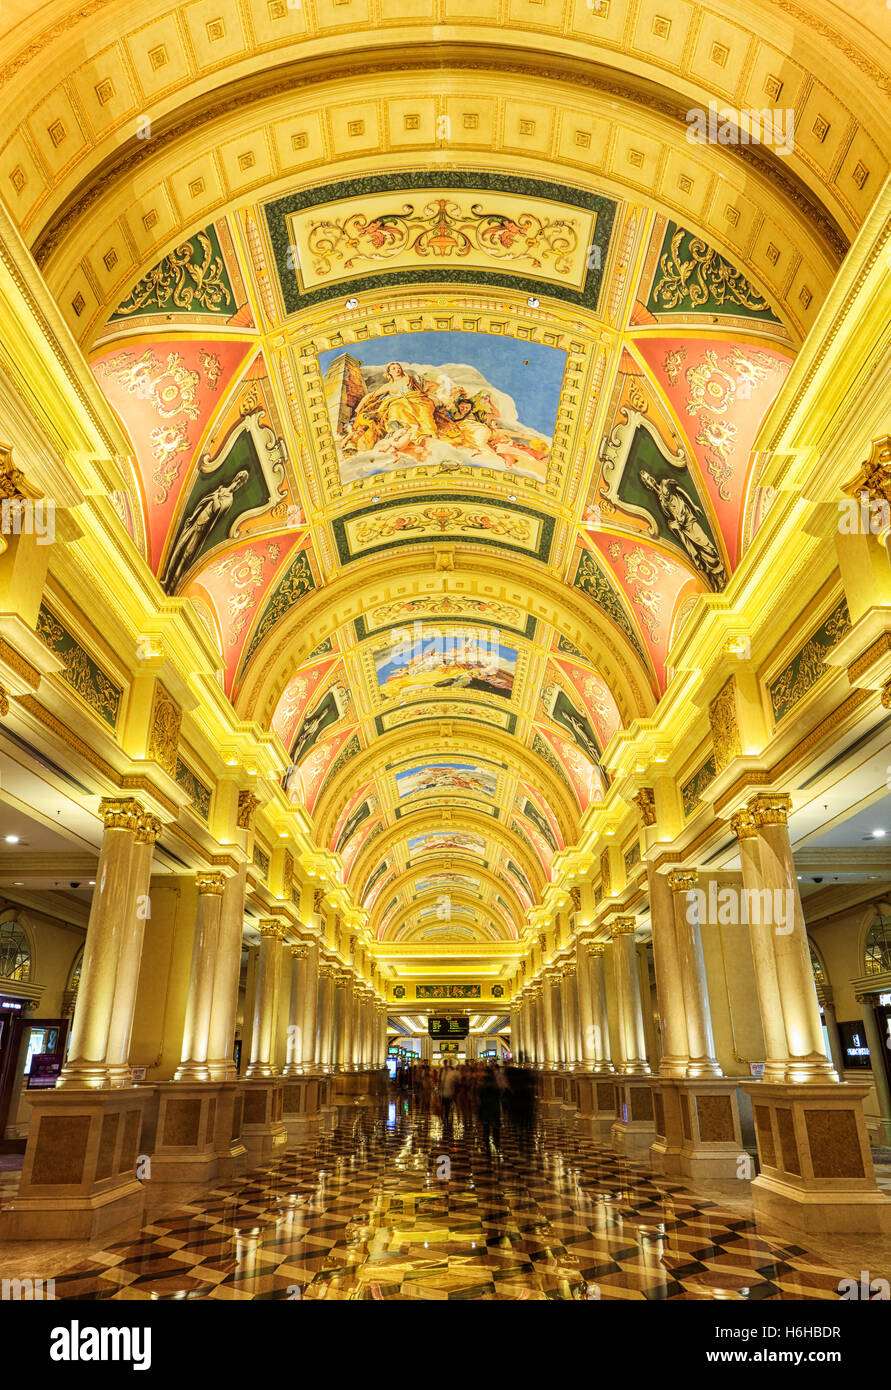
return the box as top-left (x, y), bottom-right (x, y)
top-left (649, 1076), bottom-right (751, 1183)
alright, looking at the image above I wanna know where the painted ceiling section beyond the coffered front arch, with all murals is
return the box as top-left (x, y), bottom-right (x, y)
top-left (90, 184), bottom-right (796, 947)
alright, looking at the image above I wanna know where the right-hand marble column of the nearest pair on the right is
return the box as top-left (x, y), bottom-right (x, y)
top-left (751, 795), bottom-right (838, 1081)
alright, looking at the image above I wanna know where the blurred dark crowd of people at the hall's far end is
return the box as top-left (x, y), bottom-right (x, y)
top-left (395, 1058), bottom-right (535, 1150)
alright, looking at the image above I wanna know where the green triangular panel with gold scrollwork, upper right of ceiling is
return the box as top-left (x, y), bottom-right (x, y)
top-left (646, 222), bottom-right (781, 324)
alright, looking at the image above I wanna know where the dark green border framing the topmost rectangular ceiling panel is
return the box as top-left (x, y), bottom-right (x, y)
top-left (264, 170), bottom-right (617, 314)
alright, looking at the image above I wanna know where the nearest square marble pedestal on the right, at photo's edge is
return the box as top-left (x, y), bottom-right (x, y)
top-left (742, 1081), bottom-right (891, 1233)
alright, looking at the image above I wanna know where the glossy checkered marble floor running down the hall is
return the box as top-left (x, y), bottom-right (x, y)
top-left (33, 1099), bottom-right (867, 1300)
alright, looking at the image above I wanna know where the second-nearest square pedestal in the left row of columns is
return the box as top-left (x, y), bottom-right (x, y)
top-left (143, 1081), bottom-right (220, 1183)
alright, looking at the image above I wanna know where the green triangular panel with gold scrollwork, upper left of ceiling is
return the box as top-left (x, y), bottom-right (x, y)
top-left (110, 227), bottom-right (236, 322)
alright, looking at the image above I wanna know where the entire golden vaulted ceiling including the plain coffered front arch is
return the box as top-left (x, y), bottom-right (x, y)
top-left (6, 0), bottom-right (891, 973)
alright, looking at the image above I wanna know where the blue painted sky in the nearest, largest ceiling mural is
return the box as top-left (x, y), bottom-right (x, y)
top-left (318, 334), bottom-right (566, 435)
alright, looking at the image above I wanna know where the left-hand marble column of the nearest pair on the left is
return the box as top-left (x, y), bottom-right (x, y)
top-left (56, 798), bottom-right (142, 1091)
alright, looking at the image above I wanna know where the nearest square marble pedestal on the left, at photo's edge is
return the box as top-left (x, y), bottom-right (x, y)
top-left (0, 1086), bottom-right (152, 1240)
